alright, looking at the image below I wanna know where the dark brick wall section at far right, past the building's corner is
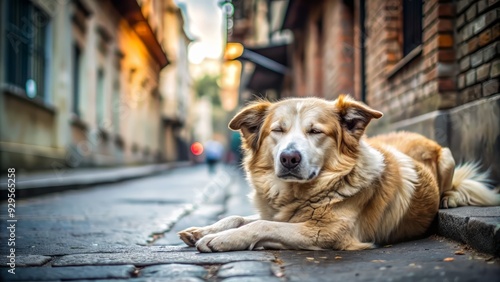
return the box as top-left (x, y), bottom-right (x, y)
top-left (456, 0), bottom-right (500, 104)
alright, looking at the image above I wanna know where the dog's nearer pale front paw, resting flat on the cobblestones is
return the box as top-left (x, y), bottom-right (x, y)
top-left (196, 230), bottom-right (253, 253)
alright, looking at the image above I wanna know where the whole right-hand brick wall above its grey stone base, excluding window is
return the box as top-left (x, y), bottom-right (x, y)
top-left (288, 0), bottom-right (500, 118)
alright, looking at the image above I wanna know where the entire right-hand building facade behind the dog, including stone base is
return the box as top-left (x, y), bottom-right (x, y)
top-left (229, 0), bottom-right (500, 182)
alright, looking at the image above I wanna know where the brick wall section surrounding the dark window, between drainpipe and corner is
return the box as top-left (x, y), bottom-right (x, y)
top-left (365, 0), bottom-right (456, 123)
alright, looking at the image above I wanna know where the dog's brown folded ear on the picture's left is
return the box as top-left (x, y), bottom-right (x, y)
top-left (229, 101), bottom-right (271, 151)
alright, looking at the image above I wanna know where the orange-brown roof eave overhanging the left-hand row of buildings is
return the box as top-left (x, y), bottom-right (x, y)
top-left (112, 0), bottom-right (169, 68)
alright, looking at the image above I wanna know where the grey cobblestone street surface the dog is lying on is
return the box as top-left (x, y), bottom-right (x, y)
top-left (0, 165), bottom-right (500, 282)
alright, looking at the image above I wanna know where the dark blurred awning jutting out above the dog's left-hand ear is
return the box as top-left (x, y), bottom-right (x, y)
top-left (240, 45), bottom-right (289, 92)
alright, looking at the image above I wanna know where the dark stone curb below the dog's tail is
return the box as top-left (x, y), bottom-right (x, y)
top-left (438, 207), bottom-right (500, 256)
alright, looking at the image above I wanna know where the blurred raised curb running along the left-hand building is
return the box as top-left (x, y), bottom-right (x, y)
top-left (0, 162), bottom-right (192, 200)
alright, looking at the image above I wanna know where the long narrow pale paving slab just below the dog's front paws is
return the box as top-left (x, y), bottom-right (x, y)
top-left (53, 251), bottom-right (274, 266)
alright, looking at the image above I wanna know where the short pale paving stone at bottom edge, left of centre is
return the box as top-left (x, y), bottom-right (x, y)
top-left (139, 264), bottom-right (208, 279)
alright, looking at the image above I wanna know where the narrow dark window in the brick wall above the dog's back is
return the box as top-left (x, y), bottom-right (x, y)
top-left (402, 0), bottom-right (422, 57)
